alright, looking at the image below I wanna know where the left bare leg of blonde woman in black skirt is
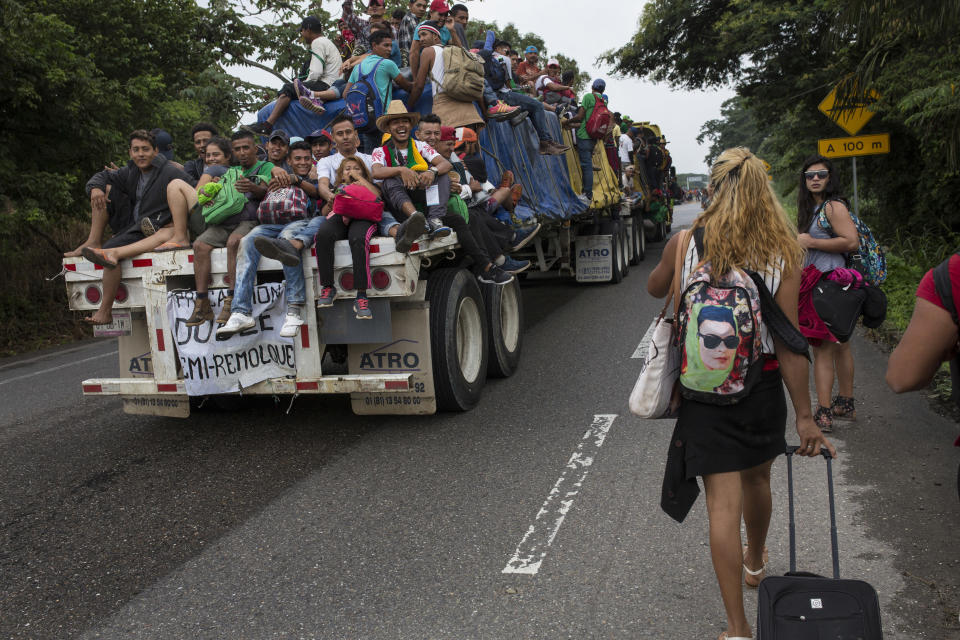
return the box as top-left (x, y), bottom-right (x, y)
top-left (703, 471), bottom-right (751, 637)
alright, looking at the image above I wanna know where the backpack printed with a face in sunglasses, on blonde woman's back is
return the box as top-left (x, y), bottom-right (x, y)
top-left (677, 229), bottom-right (763, 404)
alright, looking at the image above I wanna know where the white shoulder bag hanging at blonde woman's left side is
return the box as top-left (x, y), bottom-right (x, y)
top-left (630, 231), bottom-right (690, 418)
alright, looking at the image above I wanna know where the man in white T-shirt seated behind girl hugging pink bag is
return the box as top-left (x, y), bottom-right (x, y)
top-left (257, 114), bottom-right (426, 266)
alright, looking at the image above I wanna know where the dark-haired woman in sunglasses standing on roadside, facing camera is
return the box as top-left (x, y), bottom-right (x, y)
top-left (797, 156), bottom-right (860, 432)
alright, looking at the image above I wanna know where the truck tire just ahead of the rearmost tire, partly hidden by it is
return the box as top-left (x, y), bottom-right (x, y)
top-left (480, 276), bottom-right (523, 378)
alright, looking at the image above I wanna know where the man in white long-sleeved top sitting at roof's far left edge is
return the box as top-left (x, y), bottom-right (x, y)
top-left (241, 16), bottom-right (344, 136)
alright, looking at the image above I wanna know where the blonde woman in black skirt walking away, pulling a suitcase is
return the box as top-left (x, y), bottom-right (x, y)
top-left (647, 147), bottom-right (835, 640)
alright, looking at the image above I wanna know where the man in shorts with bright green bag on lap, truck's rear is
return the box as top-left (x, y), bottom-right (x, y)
top-left (187, 130), bottom-right (278, 326)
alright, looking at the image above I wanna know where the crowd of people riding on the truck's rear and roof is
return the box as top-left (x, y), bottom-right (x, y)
top-left (67, 0), bottom-right (666, 336)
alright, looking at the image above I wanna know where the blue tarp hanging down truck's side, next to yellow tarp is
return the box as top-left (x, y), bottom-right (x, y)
top-left (480, 111), bottom-right (587, 220)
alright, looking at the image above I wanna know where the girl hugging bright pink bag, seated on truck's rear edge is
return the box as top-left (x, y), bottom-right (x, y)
top-left (315, 157), bottom-right (383, 320)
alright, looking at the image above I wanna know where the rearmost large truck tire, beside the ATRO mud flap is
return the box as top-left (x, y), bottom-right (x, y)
top-left (427, 268), bottom-right (489, 411)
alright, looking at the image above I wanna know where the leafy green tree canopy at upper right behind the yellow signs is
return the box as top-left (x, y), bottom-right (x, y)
top-left (602, 0), bottom-right (960, 238)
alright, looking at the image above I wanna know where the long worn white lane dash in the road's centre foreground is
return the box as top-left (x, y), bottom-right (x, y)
top-left (503, 414), bottom-right (617, 575)
